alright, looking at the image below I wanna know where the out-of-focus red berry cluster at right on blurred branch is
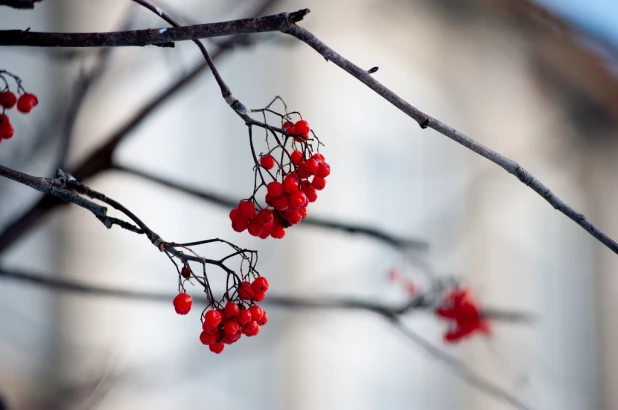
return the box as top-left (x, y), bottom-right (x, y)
top-left (435, 288), bottom-right (491, 343)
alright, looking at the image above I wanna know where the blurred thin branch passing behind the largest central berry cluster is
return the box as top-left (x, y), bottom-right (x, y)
top-left (112, 164), bottom-right (429, 250)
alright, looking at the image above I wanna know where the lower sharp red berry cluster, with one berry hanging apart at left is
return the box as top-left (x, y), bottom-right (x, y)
top-left (173, 276), bottom-right (269, 354)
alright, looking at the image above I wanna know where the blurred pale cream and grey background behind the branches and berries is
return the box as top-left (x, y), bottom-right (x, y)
top-left (0, 0), bottom-right (618, 410)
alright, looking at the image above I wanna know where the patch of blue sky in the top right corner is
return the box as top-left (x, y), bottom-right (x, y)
top-left (536, 0), bottom-right (618, 45)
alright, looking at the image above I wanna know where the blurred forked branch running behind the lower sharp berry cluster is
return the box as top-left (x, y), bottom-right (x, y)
top-left (0, 268), bottom-right (531, 410)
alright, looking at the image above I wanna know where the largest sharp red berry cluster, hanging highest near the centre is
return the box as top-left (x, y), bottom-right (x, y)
top-left (230, 120), bottom-right (330, 239)
